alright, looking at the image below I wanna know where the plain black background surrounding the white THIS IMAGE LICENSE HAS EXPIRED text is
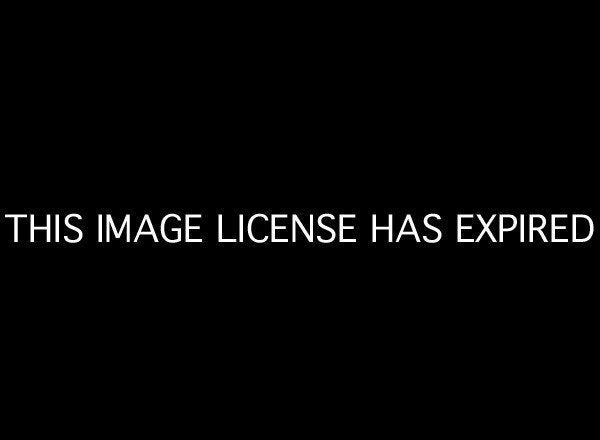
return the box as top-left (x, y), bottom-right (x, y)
top-left (1, 5), bottom-right (598, 433)
